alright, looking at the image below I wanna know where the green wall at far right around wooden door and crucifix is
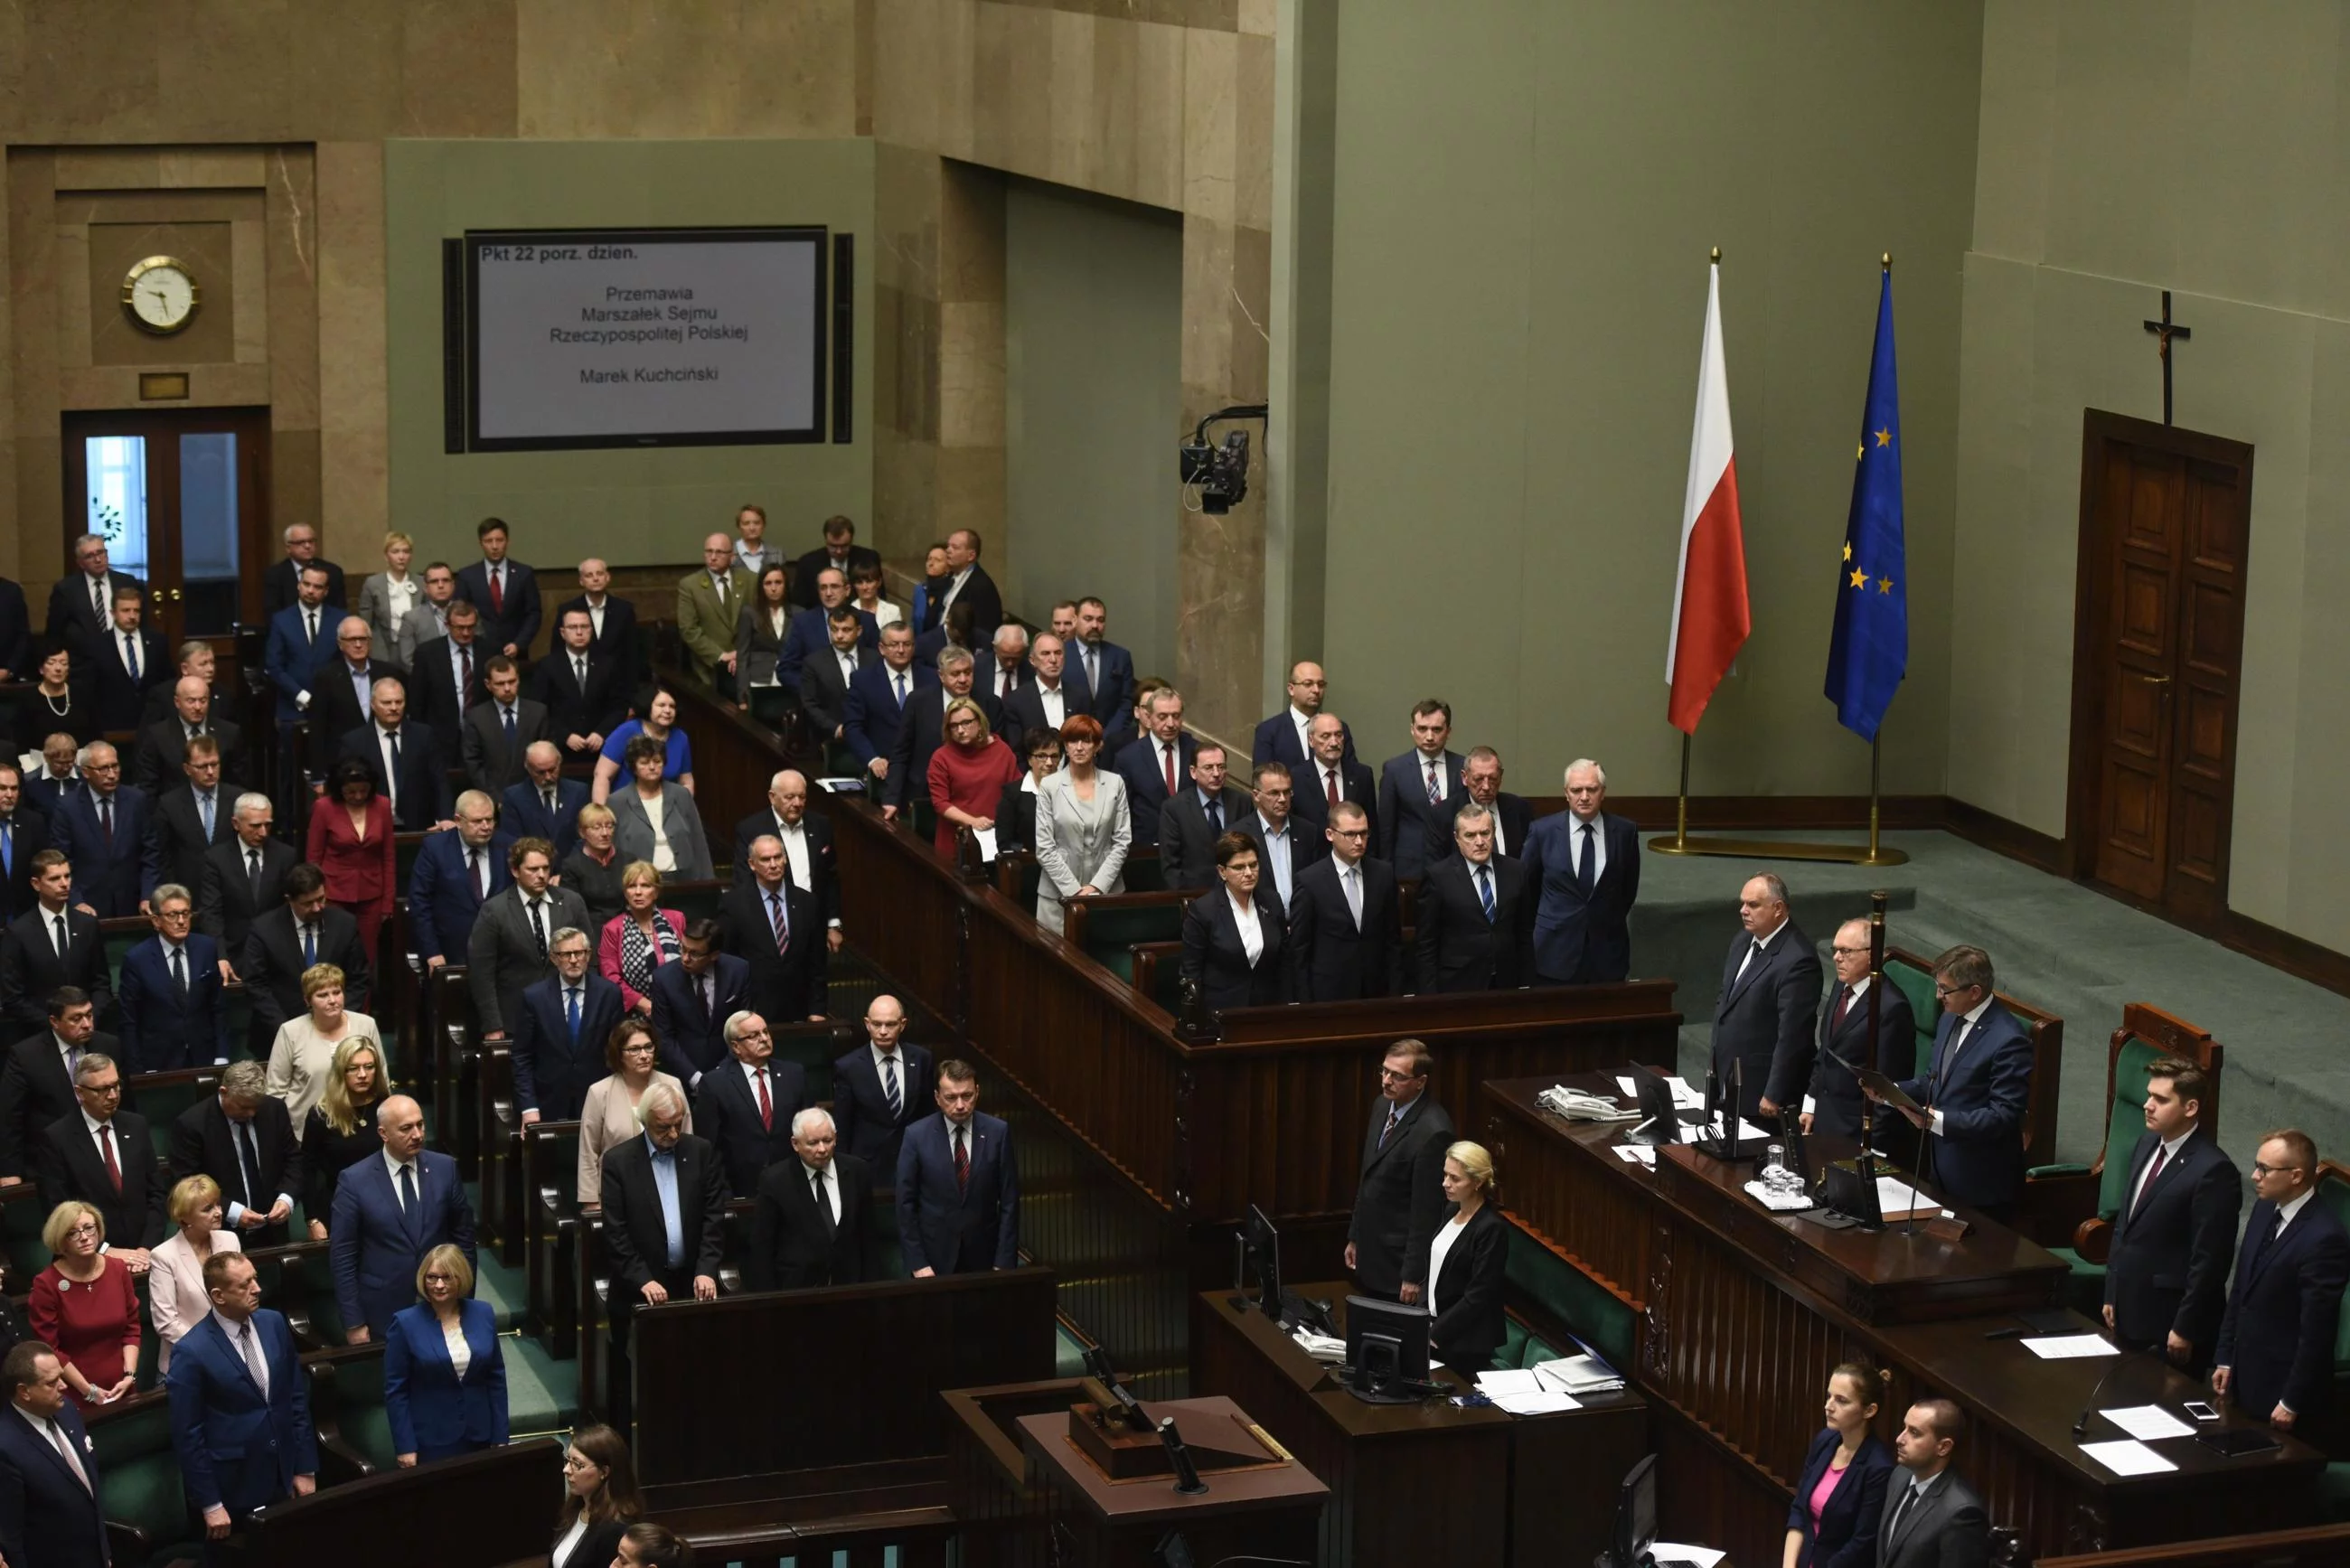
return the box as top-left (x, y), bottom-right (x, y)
top-left (1950, 0), bottom-right (2350, 950)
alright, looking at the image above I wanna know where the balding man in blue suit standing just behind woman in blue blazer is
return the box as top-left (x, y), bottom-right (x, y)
top-left (329, 1095), bottom-right (475, 1366)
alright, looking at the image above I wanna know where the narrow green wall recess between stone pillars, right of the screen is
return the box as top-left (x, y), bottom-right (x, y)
top-left (999, 181), bottom-right (1182, 675)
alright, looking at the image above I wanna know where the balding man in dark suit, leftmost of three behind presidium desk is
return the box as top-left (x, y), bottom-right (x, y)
top-left (1720, 872), bottom-right (1823, 1123)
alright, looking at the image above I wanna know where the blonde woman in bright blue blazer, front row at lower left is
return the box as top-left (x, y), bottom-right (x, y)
top-left (383, 1244), bottom-right (505, 1467)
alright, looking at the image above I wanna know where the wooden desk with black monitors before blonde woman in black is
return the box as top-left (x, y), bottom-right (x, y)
top-left (1191, 1282), bottom-right (1654, 1568)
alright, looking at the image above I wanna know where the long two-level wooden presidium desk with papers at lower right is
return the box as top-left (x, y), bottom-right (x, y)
top-left (1483, 1075), bottom-right (2322, 1561)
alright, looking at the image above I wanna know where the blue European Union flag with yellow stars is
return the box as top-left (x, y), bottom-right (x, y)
top-left (1828, 270), bottom-right (1908, 740)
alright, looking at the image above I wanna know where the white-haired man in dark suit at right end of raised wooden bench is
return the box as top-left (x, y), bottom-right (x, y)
top-left (1518, 757), bottom-right (1635, 982)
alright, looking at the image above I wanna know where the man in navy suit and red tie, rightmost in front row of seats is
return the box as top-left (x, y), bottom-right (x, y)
top-left (898, 1058), bottom-right (1020, 1279)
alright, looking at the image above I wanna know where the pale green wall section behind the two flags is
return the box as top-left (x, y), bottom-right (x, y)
top-left (1306, 0), bottom-right (1981, 794)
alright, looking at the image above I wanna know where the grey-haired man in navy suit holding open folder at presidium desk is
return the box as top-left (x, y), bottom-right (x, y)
top-left (1880, 947), bottom-right (2033, 1217)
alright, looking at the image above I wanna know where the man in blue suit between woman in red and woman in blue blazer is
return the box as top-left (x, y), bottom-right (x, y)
top-left (164, 1251), bottom-right (317, 1540)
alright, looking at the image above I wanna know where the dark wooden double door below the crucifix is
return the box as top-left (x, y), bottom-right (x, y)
top-left (2065, 409), bottom-right (2251, 928)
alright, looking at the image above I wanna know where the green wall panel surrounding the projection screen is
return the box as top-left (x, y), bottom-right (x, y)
top-left (390, 141), bottom-right (874, 571)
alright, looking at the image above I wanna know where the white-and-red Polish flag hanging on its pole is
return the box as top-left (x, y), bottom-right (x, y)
top-left (1664, 261), bottom-right (1753, 736)
